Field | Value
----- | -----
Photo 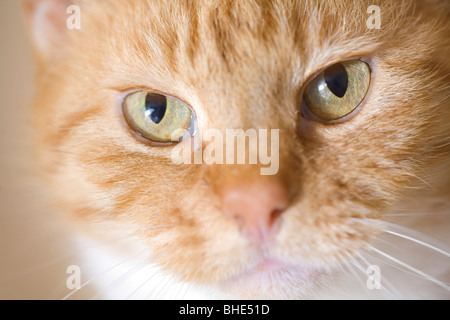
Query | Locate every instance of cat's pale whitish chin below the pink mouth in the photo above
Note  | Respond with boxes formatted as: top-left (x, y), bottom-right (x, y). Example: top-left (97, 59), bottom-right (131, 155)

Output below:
top-left (221, 259), bottom-right (324, 299)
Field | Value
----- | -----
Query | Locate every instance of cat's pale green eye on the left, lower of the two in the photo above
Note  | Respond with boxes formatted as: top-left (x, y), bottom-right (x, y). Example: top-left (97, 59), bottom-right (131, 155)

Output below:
top-left (122, 91), bottom-right (194, 142)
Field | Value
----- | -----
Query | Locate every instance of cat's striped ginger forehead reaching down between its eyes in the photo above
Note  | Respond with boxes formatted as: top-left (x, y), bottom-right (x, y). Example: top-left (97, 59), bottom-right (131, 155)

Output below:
top-left (76, 0), bottom-right (404, 125)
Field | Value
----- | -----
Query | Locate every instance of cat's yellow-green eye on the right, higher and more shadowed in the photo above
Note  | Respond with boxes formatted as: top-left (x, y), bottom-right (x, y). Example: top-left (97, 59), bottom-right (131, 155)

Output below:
top-left (303, 60), bottom-right (371, 121)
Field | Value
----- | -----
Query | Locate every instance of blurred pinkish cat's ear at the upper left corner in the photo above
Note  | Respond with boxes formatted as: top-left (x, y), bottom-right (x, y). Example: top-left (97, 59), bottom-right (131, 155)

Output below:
top-left (22, 0), bottom-right (73, 61)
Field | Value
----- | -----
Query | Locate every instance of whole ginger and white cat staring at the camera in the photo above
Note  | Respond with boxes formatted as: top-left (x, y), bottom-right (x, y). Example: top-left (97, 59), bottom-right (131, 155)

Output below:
top-left (24, 0), bottom-right (450, 299)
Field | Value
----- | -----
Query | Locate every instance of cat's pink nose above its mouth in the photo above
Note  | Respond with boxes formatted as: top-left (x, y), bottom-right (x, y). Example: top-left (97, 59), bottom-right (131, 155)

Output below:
top-left (222, 180), bottom-right (288, 241)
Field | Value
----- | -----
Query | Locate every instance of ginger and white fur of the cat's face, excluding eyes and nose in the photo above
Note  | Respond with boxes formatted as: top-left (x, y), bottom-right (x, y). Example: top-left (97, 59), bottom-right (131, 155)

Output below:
top-left (25, 0), bottom-right (450, 298)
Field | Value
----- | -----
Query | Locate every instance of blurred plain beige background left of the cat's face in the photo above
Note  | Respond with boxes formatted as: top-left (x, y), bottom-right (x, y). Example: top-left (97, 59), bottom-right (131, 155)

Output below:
top-left (0, 0), bottom-right (86, 299)
